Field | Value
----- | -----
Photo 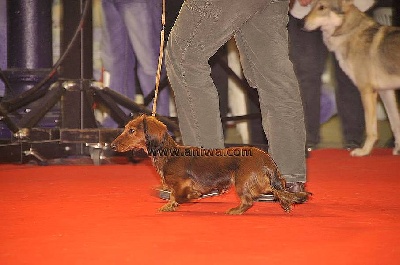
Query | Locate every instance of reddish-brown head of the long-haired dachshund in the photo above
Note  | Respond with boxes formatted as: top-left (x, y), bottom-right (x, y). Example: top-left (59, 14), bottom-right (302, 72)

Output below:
top-left (111, 115), bottom-right (168, 153)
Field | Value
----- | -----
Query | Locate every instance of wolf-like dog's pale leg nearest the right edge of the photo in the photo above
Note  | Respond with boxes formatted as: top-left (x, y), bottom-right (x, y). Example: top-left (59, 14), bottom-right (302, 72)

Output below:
top-left (378, 90), bottom-right (400, 155)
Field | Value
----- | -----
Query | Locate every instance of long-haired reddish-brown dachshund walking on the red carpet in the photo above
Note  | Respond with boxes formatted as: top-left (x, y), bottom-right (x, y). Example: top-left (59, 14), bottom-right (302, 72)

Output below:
top-left (111, 115), bottom-right (309, 214)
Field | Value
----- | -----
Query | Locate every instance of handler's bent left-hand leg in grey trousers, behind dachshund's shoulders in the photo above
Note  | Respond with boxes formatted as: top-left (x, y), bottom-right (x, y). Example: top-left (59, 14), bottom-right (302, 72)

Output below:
top-left (165, 0), bottom-right (268, 148)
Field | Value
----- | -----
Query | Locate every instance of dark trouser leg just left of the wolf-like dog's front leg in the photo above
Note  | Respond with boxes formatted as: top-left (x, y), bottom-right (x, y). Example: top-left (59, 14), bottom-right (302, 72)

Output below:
top-left (334, 58), bottom-right (365, 146)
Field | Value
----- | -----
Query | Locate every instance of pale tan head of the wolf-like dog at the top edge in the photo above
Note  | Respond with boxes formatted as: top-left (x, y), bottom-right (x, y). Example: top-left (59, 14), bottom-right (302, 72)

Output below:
top-left (304, 0), bottom-right (356, 35)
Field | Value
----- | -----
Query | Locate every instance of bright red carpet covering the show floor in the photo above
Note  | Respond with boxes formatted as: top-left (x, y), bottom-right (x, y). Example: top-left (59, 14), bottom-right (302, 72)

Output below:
top-left (0, 149), bottom-right (400, 265)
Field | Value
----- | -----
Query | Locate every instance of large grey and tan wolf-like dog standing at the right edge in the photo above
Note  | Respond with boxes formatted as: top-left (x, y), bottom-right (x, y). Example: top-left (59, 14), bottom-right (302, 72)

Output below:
top-left (305, 0), bottom-right (400, 156)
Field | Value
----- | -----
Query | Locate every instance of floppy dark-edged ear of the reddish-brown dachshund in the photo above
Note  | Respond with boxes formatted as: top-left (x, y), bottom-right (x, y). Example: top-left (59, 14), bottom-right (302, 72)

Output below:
top-left (143, 115), bottom-right (168, 153)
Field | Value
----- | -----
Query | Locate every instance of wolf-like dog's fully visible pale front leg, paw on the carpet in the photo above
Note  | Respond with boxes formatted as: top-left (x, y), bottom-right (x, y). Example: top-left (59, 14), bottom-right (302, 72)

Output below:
top-left (350, 88), bottom-right (378, 156)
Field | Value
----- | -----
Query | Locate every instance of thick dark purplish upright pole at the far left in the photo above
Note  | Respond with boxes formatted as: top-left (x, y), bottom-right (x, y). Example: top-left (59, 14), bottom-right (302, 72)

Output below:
top-left (5, 0), bottom-right (53, 98)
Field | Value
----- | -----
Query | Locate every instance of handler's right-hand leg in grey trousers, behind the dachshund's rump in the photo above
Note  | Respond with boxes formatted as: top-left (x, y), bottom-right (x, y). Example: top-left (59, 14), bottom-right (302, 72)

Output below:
top-left (236, 1), bottom-right (306, 182)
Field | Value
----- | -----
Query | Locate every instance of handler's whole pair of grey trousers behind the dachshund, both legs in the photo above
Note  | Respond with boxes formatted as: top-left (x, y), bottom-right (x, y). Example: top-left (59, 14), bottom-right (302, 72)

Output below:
top-left (165, 0), bottom-right (306, 182)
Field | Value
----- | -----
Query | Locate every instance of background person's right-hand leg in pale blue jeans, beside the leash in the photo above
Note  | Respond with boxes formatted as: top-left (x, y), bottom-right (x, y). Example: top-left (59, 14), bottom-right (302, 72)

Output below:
top-left (118, 0), bottom-right (169, 115)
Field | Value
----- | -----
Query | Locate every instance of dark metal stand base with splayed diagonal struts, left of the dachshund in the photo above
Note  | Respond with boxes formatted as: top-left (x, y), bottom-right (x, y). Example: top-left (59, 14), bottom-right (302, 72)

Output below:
top-left (0, 80), bottom-right (179, 165)
